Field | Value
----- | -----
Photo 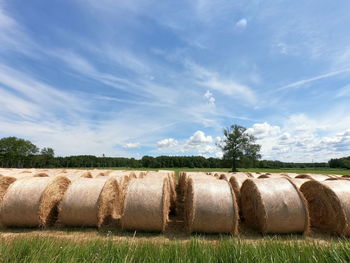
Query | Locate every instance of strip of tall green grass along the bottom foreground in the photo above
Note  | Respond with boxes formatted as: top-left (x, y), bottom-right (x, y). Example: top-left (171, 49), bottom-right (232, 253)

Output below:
top-left (0, 237), bottom-right (350, 262)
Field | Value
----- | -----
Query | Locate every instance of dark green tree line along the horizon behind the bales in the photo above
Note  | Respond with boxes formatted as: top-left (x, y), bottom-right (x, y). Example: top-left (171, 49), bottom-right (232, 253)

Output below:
top-left (0, 137), bottom-right (334, 168)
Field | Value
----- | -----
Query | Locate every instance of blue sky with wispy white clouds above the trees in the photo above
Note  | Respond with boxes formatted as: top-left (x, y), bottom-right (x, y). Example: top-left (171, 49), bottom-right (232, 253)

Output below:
top-left (0, 0), bottom-right (350, 162)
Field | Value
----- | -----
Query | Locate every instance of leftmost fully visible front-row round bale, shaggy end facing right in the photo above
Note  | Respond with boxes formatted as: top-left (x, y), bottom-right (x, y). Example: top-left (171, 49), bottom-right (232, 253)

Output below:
top-left (0, 176), bottom-right (70, 227)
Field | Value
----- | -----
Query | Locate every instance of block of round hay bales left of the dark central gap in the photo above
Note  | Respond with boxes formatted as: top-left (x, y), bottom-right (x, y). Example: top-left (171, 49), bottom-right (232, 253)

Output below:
top-left (0, 169), bottom-right (176, 231)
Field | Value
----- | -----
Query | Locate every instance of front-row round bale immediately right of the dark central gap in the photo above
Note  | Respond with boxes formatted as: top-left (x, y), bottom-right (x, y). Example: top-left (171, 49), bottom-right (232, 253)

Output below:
top-left (185, 178), bottom-right (239, 235)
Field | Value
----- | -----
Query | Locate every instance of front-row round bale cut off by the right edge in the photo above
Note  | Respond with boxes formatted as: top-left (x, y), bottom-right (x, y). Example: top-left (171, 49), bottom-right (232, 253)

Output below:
top-left (300, 180), bottom-right (350, 236)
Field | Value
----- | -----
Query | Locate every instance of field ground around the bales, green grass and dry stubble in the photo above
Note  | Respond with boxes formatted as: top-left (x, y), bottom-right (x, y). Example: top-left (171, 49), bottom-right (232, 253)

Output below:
top-left (0, 168), bottom-right (350, 262)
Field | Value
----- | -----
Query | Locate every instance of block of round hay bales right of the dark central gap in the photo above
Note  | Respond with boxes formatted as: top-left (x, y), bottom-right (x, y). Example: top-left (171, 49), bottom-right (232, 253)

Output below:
top-left (179, 173), bottom-right (350, 236)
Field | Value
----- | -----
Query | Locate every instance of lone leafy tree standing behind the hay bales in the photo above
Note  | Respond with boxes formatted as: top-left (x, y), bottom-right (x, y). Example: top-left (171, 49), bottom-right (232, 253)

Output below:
top-left (219, 124), bottom-right (261, 172)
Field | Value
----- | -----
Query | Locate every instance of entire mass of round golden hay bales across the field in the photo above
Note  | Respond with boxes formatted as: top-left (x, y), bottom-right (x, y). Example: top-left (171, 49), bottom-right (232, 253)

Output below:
top-left (0, 169), bottom-right (350, 236)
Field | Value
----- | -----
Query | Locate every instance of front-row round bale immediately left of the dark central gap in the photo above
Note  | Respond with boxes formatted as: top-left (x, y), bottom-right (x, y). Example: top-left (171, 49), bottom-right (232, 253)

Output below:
top-left (121, 178), bottom-right (170, 232)
